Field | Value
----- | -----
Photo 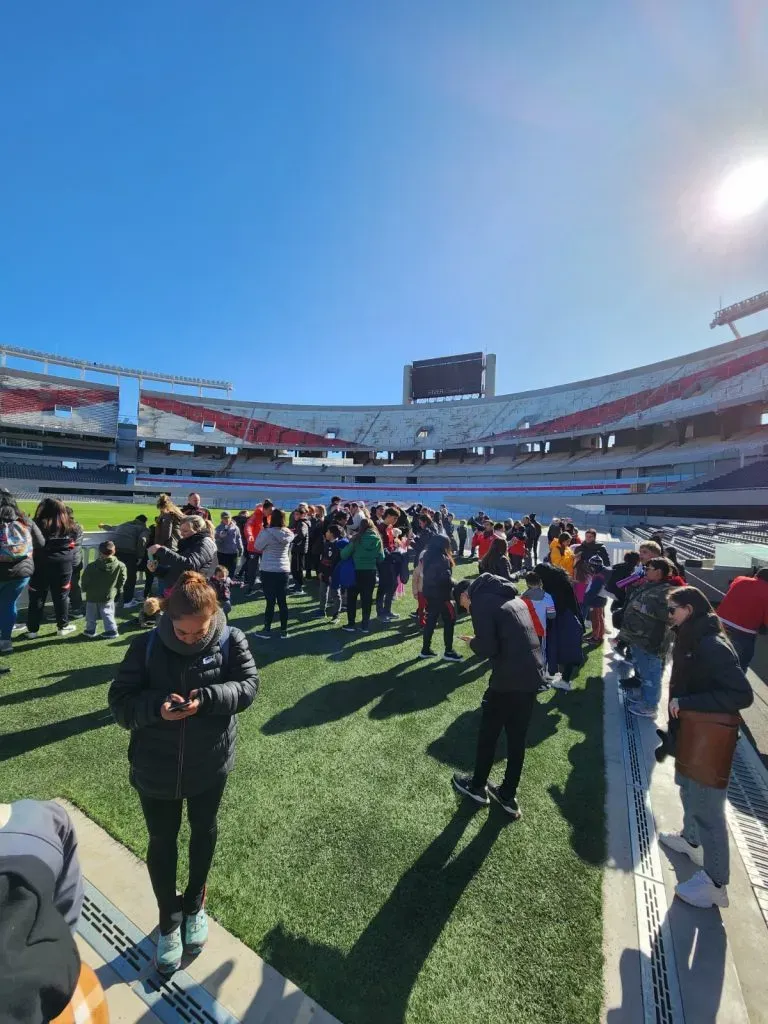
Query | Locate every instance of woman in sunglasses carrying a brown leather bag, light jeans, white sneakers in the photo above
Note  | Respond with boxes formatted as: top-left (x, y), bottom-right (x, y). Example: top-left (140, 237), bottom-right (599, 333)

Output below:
top-left (658, 587), bottom-right (754, 907)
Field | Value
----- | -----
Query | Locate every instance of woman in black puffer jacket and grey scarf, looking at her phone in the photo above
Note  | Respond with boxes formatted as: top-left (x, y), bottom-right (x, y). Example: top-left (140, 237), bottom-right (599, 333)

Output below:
top-left (108, 572), bottom-right (259, 974)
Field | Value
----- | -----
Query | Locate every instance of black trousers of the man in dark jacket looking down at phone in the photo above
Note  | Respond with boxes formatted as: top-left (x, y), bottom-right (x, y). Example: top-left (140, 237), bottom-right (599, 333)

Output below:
top-left (472, 689), bottom-right (536, 800)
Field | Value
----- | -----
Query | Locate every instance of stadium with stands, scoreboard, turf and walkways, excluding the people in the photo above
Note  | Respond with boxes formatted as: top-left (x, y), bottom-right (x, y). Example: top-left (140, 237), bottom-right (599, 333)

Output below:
top-left (0, 311), bottom-right (768, 1024)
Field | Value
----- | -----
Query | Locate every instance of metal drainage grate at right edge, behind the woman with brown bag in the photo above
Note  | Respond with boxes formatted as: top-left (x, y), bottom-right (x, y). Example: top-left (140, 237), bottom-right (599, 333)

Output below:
top-left (726, 737), bottom-right (768, 925)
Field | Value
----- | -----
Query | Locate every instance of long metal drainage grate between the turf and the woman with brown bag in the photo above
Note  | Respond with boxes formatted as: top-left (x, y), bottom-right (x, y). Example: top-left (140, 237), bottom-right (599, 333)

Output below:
top-left (618, 666), bottom-right (684, 1024)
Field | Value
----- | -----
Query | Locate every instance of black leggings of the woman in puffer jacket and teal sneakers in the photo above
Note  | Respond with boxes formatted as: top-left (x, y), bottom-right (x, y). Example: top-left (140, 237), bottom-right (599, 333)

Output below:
top-left (138, 777), bottom-right (226, 935)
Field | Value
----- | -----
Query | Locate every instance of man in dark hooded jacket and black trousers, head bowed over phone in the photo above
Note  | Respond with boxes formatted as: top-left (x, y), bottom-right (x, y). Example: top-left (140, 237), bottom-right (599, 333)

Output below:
top-left (453, 572), bottom-right (544, 819)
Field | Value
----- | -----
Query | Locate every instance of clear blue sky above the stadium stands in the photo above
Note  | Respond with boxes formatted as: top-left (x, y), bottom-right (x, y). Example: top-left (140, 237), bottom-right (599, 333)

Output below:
top-left (0, 0), bottom-right (768, 415)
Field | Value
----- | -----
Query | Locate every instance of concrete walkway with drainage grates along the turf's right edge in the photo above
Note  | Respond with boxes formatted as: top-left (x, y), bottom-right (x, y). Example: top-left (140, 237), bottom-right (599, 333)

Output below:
top-left (603, 644), bottom-right (768, 1024)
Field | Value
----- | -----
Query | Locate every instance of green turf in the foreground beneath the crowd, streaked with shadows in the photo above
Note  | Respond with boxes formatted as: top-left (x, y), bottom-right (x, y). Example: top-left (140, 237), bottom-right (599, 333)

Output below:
top-left (0, 505), bottom-right (604, 1024)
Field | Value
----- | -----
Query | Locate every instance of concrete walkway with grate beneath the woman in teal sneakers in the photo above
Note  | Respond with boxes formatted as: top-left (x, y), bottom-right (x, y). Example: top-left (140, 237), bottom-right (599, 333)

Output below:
top-left (60, 801), bottom-right (339, 1024)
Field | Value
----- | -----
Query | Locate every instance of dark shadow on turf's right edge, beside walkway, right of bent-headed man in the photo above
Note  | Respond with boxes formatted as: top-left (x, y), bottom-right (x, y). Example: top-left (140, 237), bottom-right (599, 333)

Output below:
top-left (549, 676), bottom-right (605, 864)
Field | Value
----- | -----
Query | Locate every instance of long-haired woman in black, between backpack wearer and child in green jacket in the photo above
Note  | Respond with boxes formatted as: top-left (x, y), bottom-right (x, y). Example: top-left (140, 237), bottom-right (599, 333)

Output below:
top-left (26, 498), bottom-right (75, 640)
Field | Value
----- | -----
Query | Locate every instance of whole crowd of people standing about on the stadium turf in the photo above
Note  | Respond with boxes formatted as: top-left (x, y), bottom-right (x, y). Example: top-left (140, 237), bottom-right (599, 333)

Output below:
top-left (0, 492), bottom-right (768, 999)
